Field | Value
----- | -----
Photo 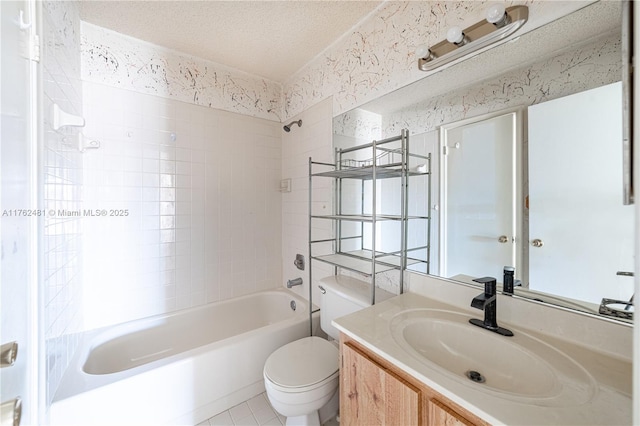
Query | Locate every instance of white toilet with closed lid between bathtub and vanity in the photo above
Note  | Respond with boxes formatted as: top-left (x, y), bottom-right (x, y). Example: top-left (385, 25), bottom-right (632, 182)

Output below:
top-left (263, 275), bottom-right (393, 425)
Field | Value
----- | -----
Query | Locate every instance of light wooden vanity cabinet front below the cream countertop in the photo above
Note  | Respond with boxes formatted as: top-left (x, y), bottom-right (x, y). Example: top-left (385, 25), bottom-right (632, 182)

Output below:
top-left (340, 335), bottom-right (488, 426)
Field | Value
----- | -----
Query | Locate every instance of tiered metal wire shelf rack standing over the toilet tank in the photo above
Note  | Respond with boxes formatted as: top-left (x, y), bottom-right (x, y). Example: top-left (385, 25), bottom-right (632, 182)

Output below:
top-left (309, 130), bottom-right (431, 304)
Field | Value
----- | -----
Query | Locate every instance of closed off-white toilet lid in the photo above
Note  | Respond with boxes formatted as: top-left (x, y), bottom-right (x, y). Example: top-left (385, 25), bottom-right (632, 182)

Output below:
top-left (264, 336), bottom-right (338, 388)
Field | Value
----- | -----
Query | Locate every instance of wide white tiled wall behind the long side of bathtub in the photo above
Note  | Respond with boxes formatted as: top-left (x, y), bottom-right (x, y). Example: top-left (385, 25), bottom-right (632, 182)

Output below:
top-left (83, 81), bottom-right (282, 329)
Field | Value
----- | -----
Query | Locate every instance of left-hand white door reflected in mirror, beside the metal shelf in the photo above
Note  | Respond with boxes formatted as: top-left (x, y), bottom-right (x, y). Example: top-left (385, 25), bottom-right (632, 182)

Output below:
top-left (440, 112), bottom-right (519, 281)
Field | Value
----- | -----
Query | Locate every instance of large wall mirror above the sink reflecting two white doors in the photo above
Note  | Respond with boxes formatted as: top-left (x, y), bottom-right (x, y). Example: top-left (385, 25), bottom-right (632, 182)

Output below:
top-left (333, 2), bottom-right (635, 320)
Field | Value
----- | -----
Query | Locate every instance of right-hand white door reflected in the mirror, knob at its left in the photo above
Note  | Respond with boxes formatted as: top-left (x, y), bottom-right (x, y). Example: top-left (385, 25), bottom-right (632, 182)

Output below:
top-left (528, 83), bottom-right (634, 304)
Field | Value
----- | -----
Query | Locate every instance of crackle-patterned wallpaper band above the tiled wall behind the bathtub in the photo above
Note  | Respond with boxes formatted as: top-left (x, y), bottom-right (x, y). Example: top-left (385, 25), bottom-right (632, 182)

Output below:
top-left (81, 22), bottom-right (282, 122)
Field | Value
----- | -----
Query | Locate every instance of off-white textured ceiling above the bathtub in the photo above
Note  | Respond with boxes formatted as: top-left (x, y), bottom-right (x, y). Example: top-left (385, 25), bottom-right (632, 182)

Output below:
top-left (80, 0), bottom-right (381, 82)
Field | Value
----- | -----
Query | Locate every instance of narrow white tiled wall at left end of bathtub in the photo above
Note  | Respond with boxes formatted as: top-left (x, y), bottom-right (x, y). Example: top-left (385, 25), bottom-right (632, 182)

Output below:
top-left (39, 1), bottom-right (83, 405)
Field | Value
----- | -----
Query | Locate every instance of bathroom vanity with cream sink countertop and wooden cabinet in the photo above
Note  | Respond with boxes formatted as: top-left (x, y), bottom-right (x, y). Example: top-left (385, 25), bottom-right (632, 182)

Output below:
top-left (334, 275), bottom-right (632, 425)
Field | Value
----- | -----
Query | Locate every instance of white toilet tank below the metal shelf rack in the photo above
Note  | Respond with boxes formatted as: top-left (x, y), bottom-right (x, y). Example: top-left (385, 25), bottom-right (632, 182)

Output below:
top-left (320, 275), bottom-right (394, 340)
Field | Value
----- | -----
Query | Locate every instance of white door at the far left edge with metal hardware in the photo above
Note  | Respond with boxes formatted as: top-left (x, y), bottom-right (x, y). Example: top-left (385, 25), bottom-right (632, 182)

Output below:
top-left (0, 1), bottom-right (37, 425)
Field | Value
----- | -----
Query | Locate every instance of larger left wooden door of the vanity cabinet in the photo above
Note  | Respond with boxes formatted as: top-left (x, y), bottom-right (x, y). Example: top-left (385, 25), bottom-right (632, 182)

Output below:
top-left (340, 343), bottom-right (421, 426)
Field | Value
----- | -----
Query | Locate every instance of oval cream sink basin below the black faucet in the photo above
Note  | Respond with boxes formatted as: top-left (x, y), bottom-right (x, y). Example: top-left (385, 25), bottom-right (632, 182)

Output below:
top-left (390, 309), bottom-right (596, 406)
